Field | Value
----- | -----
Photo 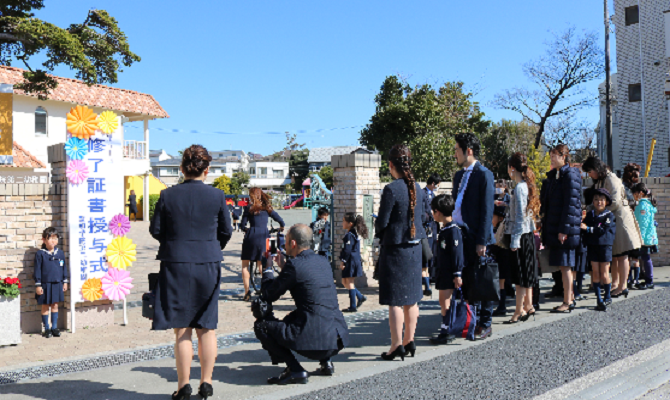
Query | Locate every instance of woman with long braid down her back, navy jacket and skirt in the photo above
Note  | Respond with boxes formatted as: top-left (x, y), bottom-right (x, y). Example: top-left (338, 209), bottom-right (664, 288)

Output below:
top-left (375, 145), bottom-right (426, 360)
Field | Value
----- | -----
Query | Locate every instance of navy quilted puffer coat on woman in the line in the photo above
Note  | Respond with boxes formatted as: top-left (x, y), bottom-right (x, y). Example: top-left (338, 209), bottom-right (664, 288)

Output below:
top-left (540, 164), bottom-right (582, 249)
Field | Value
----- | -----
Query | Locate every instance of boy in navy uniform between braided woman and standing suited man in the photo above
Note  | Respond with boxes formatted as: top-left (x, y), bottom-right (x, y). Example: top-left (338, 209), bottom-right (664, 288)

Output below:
top-left (430, 194), bottom-right (465, 344)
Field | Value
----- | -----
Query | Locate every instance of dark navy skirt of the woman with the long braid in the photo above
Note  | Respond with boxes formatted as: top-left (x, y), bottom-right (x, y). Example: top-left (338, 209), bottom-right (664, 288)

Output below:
top-left (379, 243), bottom-right (423, 307)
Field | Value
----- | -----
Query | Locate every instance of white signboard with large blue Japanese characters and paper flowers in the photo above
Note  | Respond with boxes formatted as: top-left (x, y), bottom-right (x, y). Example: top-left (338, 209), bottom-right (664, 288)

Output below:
top-left (67, 130), bottom-right (124, 304)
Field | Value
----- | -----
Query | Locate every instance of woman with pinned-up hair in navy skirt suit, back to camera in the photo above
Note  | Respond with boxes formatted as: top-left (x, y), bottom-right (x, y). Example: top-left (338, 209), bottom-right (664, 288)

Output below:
top-left (149, 145), bottom-right (233, 399)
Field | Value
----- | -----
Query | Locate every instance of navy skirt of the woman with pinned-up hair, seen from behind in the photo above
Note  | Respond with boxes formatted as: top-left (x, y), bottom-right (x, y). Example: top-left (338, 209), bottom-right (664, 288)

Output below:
top-left (152, 261), bottom-right (221, 330)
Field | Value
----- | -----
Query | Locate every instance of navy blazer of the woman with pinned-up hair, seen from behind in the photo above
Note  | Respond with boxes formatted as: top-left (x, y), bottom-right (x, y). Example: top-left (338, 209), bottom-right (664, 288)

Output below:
top-left (149, 179), bottom-right (233, 263)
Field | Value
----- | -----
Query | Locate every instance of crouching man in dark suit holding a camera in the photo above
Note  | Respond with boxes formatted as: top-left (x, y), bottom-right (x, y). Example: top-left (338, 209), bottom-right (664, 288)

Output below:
top-left (254, 224), bottom-right (349, 385)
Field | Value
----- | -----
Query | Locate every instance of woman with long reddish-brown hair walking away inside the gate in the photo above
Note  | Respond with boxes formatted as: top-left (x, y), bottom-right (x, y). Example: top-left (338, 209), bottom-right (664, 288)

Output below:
top-left (240, 188), bottom-right (284, 301)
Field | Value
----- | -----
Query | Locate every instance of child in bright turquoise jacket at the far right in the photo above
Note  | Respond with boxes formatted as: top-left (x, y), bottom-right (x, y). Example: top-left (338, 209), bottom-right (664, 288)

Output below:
top-left (632, 182), bottom-right (658, 290)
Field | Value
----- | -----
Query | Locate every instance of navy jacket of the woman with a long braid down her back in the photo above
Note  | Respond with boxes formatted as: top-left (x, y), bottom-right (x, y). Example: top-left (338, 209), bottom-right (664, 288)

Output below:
top-left (375, 179), bottom-right (426, 246)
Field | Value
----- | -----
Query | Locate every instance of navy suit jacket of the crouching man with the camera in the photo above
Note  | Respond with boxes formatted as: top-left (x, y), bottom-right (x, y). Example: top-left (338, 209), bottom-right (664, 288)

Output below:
top-left (261, 250), bottom-right (349, 350)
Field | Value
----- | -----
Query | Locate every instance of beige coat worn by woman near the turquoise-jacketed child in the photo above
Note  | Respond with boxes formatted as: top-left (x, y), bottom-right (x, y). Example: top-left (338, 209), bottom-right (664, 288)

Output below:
top-left (596, 172), bottom-right (642, 255)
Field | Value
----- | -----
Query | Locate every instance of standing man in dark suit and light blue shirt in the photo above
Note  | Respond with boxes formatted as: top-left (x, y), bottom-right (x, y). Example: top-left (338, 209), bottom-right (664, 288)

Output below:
top-left (451, 133), bottom-right (494, 339)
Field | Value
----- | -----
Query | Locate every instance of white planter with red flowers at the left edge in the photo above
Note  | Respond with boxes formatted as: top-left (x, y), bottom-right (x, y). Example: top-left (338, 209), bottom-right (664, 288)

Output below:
top-left (0, 278), bottom-right (21, 346)
